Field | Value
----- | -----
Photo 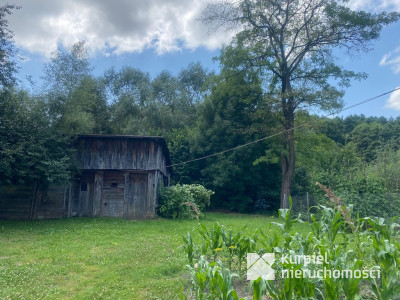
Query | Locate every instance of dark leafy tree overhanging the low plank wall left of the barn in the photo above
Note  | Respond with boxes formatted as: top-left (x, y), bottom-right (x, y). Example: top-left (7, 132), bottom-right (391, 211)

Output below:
top-left (0, 89), bottom-right (72, 187)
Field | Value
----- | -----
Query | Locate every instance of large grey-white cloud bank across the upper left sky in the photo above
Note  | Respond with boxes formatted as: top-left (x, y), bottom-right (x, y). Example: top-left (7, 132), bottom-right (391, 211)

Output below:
top-left (10, 0), bottom-right (231, 56)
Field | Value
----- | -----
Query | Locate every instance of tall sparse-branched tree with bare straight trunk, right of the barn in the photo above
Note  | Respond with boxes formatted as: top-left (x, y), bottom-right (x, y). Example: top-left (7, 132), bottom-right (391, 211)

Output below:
top-left (201, 0), bottom-right (399, 207)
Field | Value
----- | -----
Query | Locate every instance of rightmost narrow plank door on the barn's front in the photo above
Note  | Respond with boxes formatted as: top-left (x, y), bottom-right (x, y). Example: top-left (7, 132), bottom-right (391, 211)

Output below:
top-left (127, 173), bottom-right (148, 219)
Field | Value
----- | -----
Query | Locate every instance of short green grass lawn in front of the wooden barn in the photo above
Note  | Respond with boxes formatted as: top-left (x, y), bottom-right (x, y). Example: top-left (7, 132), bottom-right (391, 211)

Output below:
top-left (0, 213), bottom-right (308, 299)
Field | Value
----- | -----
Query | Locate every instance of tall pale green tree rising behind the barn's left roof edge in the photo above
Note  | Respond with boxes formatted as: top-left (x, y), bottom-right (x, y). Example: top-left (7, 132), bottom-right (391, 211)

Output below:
top-left (42, 42), bottom-right (109, 134)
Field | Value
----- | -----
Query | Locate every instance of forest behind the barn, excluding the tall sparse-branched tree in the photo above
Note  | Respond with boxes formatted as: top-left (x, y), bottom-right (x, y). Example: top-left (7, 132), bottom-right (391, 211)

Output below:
top-left (0, 5), bottom-right (400, 216)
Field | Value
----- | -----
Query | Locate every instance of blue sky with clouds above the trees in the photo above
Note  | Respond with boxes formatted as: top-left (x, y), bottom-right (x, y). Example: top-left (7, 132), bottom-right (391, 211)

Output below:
top-left (10, 0), bottom-right (400, 117)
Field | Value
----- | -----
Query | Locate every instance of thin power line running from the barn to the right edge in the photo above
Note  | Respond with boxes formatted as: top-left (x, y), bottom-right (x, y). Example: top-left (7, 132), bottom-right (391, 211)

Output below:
top-left (166, 87), bottom-right (400, 168)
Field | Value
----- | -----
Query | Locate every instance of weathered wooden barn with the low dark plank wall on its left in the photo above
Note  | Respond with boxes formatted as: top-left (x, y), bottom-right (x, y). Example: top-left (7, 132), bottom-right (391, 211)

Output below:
top-left (0, 135), bottom-right (171, 219)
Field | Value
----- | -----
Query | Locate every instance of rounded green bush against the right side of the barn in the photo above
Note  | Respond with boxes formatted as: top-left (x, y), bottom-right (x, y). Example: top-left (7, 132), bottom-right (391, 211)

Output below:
top-left (158, 184), bottom-right (214, 219)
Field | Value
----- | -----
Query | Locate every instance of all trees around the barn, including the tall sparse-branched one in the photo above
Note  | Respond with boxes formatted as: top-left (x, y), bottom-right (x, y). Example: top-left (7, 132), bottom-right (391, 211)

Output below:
top-left (0, 0), bottom-right (400, 213)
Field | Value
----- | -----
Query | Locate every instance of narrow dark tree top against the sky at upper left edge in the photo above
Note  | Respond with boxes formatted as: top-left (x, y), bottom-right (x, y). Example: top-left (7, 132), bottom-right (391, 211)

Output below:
top-left (0, 4), bottom-right (19, 88)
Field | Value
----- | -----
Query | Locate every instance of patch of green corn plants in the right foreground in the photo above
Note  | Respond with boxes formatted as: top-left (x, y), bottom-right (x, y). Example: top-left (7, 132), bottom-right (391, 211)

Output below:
top-left (184, 189), bottom-right (400, 300)
